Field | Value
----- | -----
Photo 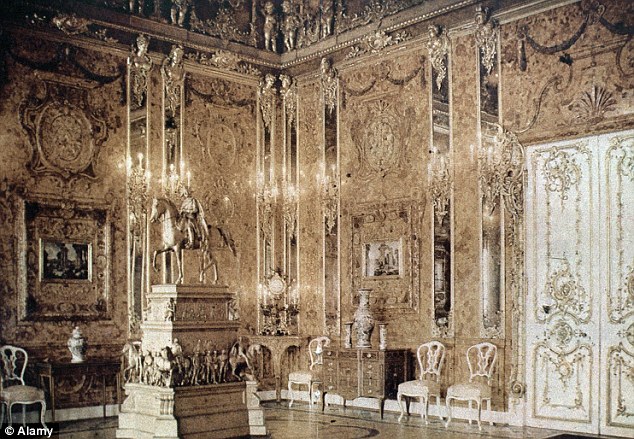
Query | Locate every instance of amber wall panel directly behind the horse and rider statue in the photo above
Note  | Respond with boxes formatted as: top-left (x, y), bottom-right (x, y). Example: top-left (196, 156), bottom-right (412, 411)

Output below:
top-left (183, 72), bottom-right (257, 334)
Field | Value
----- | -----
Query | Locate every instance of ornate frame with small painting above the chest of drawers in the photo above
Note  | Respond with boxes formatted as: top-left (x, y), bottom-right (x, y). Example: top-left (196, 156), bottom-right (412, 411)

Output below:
top-left (351, 200), bottom-right (421, 312)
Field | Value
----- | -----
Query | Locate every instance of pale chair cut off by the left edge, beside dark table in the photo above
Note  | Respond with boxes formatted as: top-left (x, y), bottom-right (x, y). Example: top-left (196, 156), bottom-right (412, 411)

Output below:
top-left (0, 345), bottom-right (46, 428)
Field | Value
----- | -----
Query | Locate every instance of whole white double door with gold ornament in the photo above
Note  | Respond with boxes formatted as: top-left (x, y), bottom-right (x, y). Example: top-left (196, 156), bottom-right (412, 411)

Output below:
top-left (525, 132), bottom-right (634, 435)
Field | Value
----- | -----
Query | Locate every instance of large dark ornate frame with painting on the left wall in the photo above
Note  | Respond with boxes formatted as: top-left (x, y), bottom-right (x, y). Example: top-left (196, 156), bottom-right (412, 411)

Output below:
top-left (17, 198), bottom-right (112, 322)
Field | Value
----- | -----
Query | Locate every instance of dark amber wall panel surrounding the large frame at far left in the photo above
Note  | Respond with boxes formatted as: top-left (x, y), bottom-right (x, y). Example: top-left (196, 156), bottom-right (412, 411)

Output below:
top-left (0, 32), bottom-right (127, 364)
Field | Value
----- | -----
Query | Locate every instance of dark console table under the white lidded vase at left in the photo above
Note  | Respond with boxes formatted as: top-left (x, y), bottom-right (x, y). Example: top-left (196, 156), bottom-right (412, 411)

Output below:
top-left (35, 359), bottom-right (121, 421)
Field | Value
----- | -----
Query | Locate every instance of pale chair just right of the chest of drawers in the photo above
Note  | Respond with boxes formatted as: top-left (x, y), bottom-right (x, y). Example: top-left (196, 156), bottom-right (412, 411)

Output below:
top-left (396, 341), bottom-right (445, 424)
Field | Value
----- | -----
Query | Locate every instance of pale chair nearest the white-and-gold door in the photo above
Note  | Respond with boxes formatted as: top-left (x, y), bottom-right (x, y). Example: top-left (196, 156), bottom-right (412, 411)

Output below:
top-left (445, 342), bottom-right (498, 430)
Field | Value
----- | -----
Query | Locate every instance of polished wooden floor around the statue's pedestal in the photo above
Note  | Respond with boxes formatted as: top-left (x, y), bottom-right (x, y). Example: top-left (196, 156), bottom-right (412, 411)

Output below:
top-left (18, 402), bottom-right (616, 439)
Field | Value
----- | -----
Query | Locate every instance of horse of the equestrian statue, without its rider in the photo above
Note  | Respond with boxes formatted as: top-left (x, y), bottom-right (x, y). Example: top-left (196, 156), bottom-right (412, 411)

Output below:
top-left (150, 198), bottom-right (236, 284)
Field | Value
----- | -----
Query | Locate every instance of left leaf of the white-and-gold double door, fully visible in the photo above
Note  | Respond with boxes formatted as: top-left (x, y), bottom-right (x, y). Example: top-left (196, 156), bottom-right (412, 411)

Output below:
top-left (526, 139), bottom-right (599, 433)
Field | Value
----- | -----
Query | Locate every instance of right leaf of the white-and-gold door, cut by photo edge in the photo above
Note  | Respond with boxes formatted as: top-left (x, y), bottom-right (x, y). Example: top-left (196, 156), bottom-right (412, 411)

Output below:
top-left (600, 132), bottom-right (634, 436)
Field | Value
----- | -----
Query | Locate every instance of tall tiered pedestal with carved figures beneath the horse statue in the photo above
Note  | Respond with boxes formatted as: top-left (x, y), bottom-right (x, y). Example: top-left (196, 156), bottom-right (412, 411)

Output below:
top-left (116, 285), bottom-right (250, 439)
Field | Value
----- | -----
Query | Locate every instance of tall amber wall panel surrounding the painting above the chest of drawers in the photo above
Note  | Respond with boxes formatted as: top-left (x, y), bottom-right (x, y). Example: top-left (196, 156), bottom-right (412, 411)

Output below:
top-left (340, 50), bottom-right (431, 347)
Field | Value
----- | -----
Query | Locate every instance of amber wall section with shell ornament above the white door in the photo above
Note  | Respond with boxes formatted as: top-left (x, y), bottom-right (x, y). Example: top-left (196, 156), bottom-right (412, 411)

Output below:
top-left (500, 0), bottom-right (634, 143)
